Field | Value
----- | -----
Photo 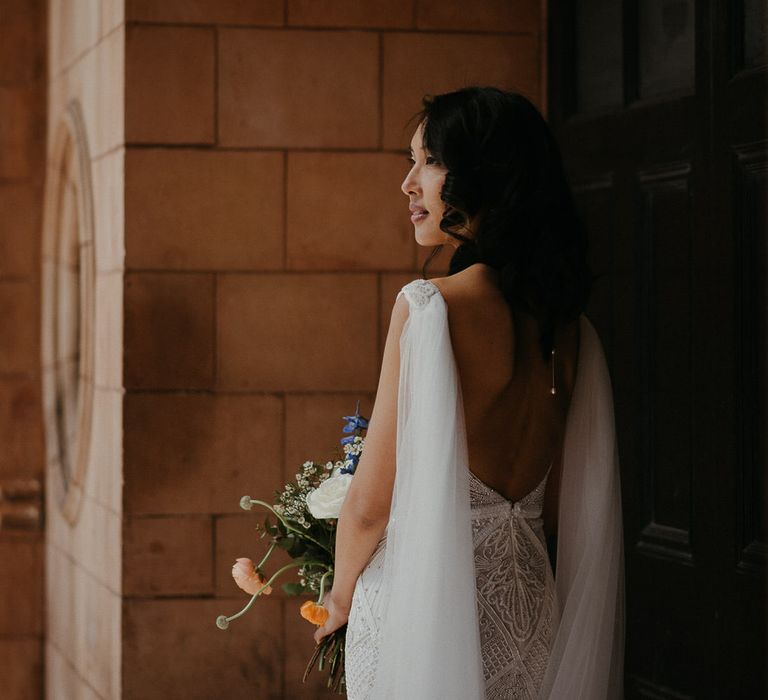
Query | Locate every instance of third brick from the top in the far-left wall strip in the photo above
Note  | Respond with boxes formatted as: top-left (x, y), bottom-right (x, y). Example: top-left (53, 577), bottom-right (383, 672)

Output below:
top-left (0, 183), bottom-right (42, 278)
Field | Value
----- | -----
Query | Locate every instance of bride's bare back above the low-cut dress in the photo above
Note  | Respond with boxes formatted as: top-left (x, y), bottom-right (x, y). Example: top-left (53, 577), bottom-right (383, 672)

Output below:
top-left (430, 264), bottom-right (579, 532)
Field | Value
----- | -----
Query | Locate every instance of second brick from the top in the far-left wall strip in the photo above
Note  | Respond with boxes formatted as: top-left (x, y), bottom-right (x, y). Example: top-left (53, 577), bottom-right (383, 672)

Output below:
top-left (0, 85), bottom-right (39, 180)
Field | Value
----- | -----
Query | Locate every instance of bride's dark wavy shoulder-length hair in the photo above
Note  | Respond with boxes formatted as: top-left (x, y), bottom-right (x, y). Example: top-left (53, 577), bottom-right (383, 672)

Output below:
top-left (409, 86), bottom-right (596, 360)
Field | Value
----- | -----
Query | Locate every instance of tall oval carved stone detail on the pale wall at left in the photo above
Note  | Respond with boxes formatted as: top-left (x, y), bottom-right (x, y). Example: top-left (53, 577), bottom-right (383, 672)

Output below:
top-left (42, 100), bottom-right (95, 524)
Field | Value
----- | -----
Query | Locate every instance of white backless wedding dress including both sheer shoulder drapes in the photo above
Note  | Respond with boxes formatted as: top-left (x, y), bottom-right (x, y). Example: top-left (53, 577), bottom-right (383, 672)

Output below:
top-left (345, 279), bottom-right (624, 700)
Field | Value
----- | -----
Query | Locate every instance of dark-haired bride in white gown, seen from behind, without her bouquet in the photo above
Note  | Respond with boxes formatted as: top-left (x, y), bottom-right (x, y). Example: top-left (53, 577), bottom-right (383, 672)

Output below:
top-left (315, 87), bottom-right (624, 700)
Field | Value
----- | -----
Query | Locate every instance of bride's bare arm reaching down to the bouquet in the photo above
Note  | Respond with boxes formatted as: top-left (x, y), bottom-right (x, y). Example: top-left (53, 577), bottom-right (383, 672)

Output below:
top-left (316, 294), bottom-right (408, 638)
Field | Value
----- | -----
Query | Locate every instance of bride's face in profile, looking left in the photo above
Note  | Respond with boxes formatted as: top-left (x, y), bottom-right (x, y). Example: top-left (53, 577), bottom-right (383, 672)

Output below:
top-left (400, 123), bottom-right (459, 247)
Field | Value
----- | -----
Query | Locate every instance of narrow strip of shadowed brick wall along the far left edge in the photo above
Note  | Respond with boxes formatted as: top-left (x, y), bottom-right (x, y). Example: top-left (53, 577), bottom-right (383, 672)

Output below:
top-left (0, 0), bottom-right (45, 700)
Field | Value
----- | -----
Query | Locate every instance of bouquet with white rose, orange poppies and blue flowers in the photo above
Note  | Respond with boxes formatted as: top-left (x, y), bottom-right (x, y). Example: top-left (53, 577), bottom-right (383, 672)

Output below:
top-left (216, 401), bottom-right (368, 693)
